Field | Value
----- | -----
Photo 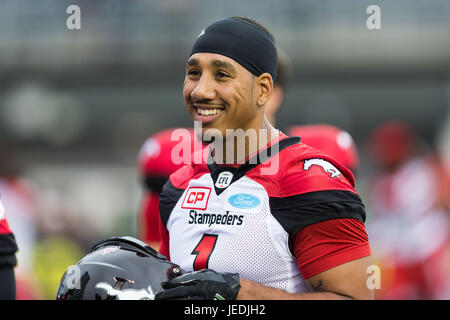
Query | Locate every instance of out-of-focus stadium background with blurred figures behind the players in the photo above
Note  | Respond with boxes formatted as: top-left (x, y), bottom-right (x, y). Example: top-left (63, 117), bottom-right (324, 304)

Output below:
top-left (0, 0), bottom-right (450, 299)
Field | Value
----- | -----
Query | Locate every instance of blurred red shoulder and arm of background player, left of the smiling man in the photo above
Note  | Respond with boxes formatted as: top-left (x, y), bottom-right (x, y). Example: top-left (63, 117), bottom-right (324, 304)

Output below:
top-left (138, 128), bottom-right (202, 250)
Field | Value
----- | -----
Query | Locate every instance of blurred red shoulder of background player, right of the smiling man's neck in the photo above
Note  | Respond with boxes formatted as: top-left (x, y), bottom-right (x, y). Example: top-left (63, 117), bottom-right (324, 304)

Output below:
top-left (288, 124), bottom-right (359, 174)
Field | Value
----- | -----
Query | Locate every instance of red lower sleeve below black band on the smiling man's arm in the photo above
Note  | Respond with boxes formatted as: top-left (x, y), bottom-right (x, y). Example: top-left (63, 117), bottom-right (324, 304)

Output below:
top-left (294, 219), bottom-right (371, 279)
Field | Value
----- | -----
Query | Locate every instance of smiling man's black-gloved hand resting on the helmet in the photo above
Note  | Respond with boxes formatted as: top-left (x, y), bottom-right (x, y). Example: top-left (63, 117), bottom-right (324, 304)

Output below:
top-left (155, 269), bottom-right (241, 300)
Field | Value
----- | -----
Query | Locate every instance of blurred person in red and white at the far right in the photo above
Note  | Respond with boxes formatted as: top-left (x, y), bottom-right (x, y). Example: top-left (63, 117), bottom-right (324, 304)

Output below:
top-left (368, 122), bottom-right (450, 299)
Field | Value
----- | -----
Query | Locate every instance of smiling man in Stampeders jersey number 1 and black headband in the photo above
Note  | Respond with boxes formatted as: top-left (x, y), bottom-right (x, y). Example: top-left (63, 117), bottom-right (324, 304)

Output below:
top-left (156, 17), bottom-right (373, 299)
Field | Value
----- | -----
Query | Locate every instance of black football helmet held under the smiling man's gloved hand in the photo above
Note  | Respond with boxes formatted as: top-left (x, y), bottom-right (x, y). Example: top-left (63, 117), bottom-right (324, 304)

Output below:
top-left (56, 236), bottom-right (185, 300)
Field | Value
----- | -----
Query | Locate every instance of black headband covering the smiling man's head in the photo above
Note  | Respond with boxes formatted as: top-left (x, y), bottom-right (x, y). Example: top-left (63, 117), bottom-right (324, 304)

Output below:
top-left (191, 17), bottom-right (277, 82)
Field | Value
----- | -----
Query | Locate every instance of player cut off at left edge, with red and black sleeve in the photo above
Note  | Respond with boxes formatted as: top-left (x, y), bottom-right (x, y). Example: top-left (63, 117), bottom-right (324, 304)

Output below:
top-left (0, 199), bottom-right (17, 300)
